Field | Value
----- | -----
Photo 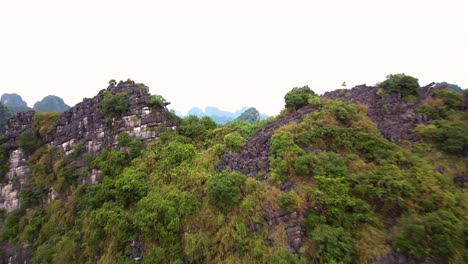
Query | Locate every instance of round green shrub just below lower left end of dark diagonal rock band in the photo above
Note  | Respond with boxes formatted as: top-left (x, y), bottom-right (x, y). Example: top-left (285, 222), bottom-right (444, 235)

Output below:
top-left (206, 171), bottom-right (245, 211)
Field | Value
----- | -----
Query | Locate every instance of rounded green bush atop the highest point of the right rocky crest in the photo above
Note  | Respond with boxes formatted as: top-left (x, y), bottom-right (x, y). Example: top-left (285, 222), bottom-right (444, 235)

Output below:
top-left (381, 73), bottom-right (421, 98)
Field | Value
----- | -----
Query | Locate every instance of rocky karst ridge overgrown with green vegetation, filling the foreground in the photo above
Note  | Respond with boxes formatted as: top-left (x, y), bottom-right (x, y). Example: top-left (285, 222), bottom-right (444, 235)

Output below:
top-left (1, 77), bottom-right (468, 263)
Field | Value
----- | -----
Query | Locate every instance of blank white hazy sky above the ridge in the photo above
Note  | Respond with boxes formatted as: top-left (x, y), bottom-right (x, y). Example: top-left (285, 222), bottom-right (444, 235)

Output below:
top-left (0, 0), bottom-right (468, 114)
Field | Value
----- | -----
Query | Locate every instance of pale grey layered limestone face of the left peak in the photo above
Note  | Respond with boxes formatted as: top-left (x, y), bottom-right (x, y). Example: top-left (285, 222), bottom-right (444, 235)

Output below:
top-left (51, 83), bottom-right (175, 154)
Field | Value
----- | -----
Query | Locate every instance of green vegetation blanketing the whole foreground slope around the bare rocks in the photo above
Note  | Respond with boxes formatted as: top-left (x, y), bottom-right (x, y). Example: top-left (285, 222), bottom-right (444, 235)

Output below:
top-left (0, 82), bottom-right (468, 263)
